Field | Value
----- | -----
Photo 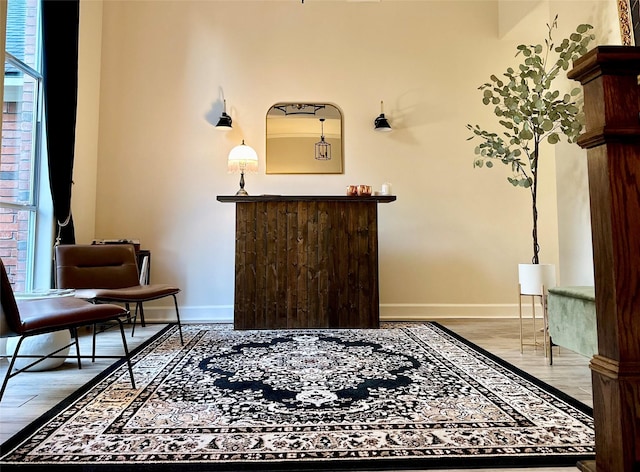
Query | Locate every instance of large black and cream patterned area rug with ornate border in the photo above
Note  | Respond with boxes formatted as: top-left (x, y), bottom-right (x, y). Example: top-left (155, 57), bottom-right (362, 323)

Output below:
top-left (0, 323), bottom-right (594, 472)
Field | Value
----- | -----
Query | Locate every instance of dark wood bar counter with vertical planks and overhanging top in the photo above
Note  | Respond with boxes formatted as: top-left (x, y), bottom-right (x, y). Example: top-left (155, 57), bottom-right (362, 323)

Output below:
top-left (217, 195), bottom-right (396, 329)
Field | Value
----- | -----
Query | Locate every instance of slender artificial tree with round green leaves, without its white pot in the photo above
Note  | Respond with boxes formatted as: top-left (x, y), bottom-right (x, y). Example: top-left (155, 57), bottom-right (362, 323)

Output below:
top-left (467, 16), bottom-right (595, 264)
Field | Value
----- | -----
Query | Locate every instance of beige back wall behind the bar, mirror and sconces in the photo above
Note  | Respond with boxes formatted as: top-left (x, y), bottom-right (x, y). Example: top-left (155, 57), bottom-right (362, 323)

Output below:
top-left (74, 0), bottom-right (619, 319)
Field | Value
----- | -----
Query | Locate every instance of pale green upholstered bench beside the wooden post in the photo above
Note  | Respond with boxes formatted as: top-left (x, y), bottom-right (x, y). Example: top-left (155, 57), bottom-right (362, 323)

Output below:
top-left (547, 286), bottom-right (598, 357)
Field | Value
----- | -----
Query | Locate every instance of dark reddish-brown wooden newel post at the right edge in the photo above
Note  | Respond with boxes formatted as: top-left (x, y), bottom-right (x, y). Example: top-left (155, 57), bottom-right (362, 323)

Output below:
top-left (569, 46), bottom-right (640, 472)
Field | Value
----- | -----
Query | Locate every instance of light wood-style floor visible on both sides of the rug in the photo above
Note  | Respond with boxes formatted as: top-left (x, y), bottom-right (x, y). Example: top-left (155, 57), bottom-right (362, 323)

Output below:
top-left (0, 319), bottom-right (592, 472)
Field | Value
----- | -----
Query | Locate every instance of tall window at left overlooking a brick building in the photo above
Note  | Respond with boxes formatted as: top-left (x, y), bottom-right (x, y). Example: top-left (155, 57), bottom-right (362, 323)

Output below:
top-left (0, 0), bottom-right (51, 292)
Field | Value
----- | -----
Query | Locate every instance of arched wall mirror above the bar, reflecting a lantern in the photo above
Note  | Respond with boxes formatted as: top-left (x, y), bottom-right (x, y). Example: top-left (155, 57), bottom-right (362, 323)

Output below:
top-left (266, 103), bottom-right (343, 174)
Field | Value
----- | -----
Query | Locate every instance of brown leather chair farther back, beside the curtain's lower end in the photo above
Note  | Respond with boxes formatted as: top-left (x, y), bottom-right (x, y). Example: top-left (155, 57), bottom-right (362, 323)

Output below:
top-left (55, 244), bottom-right (184, 344)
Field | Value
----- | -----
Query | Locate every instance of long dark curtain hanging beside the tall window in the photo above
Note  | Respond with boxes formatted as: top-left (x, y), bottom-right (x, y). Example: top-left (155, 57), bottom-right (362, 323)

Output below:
top-left (42, 0), bottom-right (80, 244)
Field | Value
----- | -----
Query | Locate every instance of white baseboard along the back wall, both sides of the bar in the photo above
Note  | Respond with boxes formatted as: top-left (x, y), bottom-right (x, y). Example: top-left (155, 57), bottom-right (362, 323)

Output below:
top-left (135, 299), bottom-right (542, 323)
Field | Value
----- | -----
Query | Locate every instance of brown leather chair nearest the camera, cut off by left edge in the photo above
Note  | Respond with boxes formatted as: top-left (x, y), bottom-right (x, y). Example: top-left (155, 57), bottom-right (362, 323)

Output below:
top-left (0, 259), bottom-right (136, 399)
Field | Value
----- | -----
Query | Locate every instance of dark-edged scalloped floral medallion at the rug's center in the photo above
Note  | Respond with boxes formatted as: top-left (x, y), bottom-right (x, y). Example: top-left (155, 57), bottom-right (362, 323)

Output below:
top-left (199, 334), bottom-right (420, 409)
